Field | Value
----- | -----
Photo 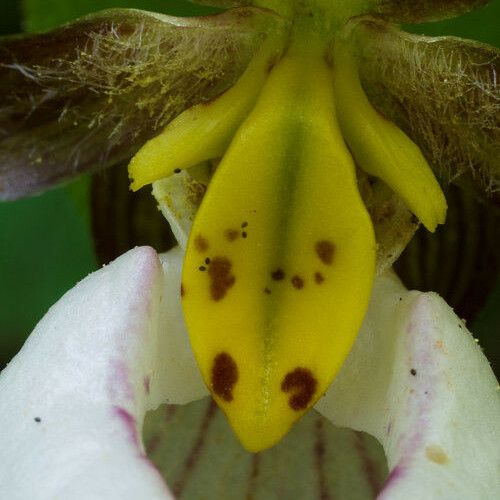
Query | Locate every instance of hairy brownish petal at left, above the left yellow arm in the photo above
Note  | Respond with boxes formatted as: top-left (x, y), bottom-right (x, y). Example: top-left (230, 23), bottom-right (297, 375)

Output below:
top-left (0, 8), bottom-right (274, 199)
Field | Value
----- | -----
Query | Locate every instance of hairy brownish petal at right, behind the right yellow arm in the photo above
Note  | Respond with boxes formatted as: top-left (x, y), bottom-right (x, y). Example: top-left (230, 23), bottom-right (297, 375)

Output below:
top-left (356, 19), bottom-right (500, 197)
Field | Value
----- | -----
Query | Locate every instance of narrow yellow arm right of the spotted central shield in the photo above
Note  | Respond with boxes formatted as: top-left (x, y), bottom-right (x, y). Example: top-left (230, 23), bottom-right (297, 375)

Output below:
top-left (334, 36), bottom-right (447, 232)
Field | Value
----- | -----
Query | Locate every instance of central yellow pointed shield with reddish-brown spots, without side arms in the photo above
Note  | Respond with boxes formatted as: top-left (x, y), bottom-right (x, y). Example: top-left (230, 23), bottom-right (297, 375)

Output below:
top-left (183, 41), bottom-right (375, 452)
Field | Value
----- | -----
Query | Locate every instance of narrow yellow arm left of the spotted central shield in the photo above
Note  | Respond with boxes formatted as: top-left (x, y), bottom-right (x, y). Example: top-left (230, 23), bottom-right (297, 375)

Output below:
top-left (129, 33), bottom-right (282, 191)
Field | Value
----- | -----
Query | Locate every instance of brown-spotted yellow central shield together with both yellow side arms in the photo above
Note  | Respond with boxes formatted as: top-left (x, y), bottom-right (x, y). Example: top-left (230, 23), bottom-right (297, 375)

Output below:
top-left (130, 26), bottom-right (446, 451)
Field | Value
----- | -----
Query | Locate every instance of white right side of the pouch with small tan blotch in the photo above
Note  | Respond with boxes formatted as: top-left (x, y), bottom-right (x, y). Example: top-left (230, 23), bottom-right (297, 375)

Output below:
top-left (317, 275), bottom-right (500, 500)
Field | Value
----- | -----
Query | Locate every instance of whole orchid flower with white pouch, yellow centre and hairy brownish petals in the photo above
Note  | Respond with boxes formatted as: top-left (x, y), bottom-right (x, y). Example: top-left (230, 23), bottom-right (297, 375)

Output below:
top-left (0, 0), bottom-right (500, 499)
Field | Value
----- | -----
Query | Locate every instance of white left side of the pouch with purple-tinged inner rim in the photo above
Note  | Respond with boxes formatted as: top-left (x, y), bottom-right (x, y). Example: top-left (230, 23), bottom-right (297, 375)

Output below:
top-left (0, 247), bottom-right (205, 500)
